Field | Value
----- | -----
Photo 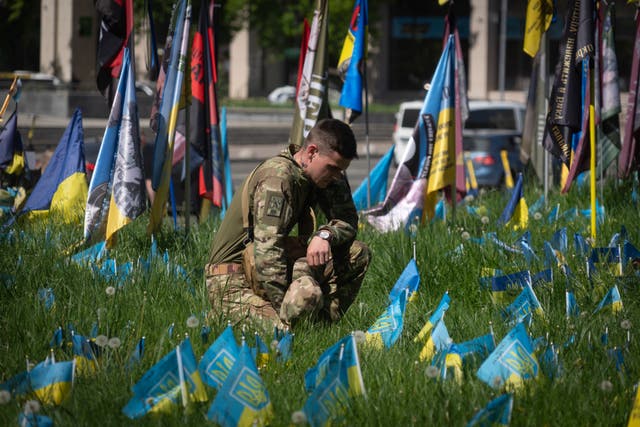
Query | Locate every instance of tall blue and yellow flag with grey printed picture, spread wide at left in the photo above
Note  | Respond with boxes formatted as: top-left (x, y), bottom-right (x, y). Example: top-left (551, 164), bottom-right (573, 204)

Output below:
top-left (84, 48), bottom-right (147, 247)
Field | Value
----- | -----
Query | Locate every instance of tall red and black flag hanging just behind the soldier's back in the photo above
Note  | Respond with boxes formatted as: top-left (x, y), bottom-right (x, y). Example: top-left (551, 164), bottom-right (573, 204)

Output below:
top-left (190, 0), bottom-right (224, 207)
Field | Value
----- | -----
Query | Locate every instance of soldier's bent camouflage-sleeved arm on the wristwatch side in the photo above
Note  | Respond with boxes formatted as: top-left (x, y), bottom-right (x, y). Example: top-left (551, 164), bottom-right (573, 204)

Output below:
top-left (318, 177), bottom-right (358, 246)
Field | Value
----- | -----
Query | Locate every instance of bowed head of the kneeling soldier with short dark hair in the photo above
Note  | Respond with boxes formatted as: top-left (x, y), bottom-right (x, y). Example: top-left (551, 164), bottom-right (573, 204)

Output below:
top-left (296, 119), bottom-right (358, 188)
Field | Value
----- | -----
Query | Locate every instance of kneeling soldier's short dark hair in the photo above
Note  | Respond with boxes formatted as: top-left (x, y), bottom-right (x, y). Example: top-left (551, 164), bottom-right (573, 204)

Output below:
top-left (304, 119), bottom-right (358, 160)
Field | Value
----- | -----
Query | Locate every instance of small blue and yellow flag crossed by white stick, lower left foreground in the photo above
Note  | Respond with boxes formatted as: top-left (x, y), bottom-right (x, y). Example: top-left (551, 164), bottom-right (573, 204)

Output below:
top-left (122, 338), bottom-right (207, 419)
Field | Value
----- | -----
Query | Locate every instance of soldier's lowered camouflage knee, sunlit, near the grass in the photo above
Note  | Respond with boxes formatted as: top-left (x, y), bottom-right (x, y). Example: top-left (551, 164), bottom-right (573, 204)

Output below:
top-left (280, 276), bottom-right (323, 325)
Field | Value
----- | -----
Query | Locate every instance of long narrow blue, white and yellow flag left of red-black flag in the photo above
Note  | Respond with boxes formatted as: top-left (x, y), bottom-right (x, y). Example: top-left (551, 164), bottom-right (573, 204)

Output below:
top-left (147, 0), bottom-right (191, 234)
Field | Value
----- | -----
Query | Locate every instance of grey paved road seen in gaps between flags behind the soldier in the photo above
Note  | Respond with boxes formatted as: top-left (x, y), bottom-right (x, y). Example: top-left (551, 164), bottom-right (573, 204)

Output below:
top-left (18, 111), bottom-right (393, 189)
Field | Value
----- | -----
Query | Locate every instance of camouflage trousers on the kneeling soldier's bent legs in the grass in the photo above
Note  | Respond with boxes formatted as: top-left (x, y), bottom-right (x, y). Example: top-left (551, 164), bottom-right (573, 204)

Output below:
top-left (206, 240), bottom-right (371, 328)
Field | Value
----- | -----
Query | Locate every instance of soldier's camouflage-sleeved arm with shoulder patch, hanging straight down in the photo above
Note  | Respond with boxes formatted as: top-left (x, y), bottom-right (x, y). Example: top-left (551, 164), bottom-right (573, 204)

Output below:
top-left (253, 176), bottom-right (292, 311)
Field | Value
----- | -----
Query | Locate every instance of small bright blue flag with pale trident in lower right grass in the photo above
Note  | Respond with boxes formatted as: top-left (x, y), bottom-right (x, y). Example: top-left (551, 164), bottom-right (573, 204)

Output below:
top-left (477, 323), bottom-right (539, 389)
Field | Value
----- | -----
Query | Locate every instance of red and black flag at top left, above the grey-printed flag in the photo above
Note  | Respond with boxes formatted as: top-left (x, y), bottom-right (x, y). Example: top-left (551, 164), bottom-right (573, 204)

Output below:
top-left (95, 0), bottom-right (133, 105)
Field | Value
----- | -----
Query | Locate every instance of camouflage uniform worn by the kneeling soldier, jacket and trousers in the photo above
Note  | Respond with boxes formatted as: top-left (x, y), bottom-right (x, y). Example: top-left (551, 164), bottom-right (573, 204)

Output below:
top-left (205, 146), bottom-right (370, 326)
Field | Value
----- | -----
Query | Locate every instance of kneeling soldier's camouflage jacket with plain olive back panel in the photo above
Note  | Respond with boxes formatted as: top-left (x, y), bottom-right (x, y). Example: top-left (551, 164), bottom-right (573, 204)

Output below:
top-left (209, 150), bottom-right (358, 309)
